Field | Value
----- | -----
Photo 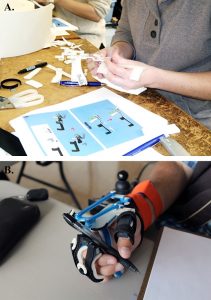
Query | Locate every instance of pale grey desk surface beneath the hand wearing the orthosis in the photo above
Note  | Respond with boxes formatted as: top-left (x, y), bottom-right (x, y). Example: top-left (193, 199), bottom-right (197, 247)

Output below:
top-left (0, 181), bottom-right (153, 300)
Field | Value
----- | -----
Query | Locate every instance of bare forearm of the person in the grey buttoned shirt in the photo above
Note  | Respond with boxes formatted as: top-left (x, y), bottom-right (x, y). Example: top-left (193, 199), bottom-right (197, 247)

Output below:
top-left (146, 68), bottom-right (211, 100)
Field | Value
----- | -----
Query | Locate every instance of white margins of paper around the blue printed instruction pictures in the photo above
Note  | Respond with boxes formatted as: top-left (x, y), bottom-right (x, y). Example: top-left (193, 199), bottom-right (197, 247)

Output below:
top-left (10, 88), bottom-right (178, 160)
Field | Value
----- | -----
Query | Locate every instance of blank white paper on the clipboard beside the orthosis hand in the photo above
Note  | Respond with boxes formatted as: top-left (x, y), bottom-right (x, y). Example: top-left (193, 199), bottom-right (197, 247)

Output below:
top-left (144, 228), bottom-right (211, 300)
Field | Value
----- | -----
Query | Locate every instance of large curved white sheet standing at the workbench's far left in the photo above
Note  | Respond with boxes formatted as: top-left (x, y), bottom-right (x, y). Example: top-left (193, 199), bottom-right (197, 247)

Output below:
top-left (0, 4), bottom-right (54, 58)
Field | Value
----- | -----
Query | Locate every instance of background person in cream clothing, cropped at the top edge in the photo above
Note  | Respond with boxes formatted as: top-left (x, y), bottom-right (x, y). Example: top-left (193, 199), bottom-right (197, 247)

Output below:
top-left (37, 0), bottom-right (111, 48)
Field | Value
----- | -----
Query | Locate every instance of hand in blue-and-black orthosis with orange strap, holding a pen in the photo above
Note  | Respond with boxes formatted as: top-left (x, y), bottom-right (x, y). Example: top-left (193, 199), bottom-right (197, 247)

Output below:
top-left (64, 171), bottom-right (162, 282)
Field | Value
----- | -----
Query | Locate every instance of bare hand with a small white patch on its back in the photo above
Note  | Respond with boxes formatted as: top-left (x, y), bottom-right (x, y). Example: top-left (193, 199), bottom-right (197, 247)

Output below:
top-left (98, 55), bottom-right (159, 89)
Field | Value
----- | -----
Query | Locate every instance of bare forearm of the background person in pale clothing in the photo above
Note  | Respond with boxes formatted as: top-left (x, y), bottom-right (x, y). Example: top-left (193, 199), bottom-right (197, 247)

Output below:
top-left (55, 0), bottom-right (101, 22)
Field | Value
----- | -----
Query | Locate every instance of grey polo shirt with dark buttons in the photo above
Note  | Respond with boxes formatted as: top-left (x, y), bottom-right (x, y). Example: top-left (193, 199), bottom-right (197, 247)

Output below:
top-left (112, 0), bottom-right (211, 129)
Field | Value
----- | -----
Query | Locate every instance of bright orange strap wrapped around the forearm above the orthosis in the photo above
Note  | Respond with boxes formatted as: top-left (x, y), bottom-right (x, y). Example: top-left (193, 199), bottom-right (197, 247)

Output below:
top-left (128, 180), bottom-right (163, 230)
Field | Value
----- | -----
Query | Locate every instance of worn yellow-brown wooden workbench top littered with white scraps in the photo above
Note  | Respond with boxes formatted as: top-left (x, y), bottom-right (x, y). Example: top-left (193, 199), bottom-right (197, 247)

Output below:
top-left (0, 36), bottom-right (211, 156)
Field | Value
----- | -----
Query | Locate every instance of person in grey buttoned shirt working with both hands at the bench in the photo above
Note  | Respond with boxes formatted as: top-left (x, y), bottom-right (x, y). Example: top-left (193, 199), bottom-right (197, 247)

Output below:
top-left (88, 0), bottom-right (211, 129)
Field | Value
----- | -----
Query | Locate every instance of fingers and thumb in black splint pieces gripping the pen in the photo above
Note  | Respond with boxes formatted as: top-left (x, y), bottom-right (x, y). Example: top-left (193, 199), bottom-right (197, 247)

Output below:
top-left (71, 208), bottom-right (144, 282)
